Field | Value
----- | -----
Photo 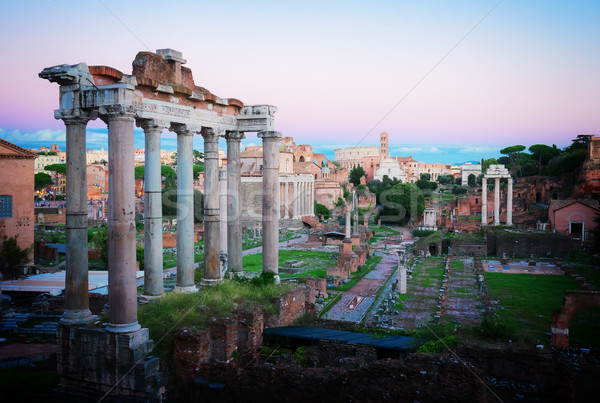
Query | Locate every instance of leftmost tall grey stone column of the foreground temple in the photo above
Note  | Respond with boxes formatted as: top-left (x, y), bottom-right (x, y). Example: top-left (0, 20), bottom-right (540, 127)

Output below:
top-left (60, 116), bottom-right (93, 325)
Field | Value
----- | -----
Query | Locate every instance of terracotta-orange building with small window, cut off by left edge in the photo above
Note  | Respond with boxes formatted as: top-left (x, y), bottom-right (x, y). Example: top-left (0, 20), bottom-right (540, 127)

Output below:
top-left (0, 139), bottom-right (36, 258)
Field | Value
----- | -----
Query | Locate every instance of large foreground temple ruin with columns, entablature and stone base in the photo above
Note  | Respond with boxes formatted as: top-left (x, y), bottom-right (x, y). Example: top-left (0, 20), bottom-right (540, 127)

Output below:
top-left (39, 49), bottom-right (281, 400)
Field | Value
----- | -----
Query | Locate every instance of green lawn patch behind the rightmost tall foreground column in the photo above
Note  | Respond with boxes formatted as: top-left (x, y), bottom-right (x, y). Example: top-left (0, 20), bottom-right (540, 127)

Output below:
top-left (242, 250), bottom-right (337, 278)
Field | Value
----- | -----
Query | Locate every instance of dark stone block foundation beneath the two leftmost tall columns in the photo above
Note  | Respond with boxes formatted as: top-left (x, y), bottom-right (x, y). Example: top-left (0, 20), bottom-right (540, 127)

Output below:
top-left (57, 325), bottom-right (166, 402)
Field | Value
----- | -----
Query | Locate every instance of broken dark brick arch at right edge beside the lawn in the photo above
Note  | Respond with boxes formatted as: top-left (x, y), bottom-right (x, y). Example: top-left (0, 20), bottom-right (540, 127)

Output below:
top-left (550, 290), bottom-right (600, 348)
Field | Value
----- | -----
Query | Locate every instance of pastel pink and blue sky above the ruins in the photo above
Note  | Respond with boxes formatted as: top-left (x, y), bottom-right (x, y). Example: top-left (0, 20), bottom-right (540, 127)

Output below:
top-left (0, 0), bottom-right (600, 163)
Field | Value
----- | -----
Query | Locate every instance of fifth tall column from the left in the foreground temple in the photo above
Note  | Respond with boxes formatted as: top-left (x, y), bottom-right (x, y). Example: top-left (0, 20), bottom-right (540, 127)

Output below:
top-left (202, 127), bottom-right (221, 284)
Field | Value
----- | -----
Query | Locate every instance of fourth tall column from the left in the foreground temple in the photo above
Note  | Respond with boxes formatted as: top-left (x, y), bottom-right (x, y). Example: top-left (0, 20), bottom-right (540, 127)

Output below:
top-left (173, 125), bottom-right (196, 292)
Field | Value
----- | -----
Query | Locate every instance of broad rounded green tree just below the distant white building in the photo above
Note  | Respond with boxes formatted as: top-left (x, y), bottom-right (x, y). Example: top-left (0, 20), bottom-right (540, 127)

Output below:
top-left (379, 183), bottom-right (425, 225)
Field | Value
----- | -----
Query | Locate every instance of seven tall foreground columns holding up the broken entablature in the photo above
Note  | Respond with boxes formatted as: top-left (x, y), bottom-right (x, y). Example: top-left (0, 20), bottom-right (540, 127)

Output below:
top-left (61, 105), bottom-right (281, 333)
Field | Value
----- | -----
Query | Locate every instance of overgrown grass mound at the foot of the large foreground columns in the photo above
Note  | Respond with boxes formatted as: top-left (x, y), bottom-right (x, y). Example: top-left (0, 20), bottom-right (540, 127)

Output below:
top-left (138, 280), bottom-right (292, 357)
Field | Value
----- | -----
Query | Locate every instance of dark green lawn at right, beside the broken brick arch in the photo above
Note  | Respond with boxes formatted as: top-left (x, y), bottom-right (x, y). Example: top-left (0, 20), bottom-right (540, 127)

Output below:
top-left (485, 273), bottom-right (579, 342)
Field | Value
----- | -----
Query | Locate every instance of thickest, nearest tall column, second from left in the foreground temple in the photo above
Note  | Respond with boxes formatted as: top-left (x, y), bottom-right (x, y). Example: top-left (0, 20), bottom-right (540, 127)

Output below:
top-left (100, 105), bottom-right (141, 333)
